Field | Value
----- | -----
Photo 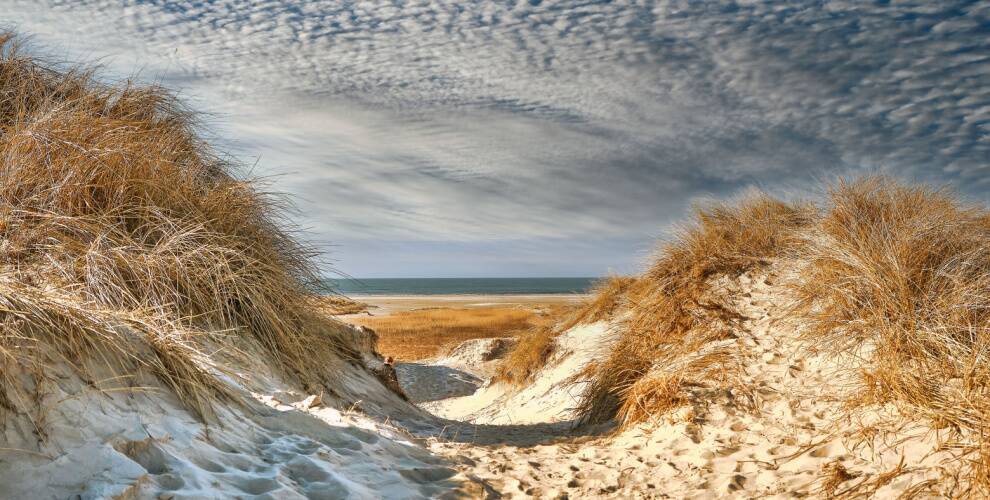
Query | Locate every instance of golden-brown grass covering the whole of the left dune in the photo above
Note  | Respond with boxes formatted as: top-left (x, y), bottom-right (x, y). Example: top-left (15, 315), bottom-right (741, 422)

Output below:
top-left (0, 34), bottom-right (349, 422)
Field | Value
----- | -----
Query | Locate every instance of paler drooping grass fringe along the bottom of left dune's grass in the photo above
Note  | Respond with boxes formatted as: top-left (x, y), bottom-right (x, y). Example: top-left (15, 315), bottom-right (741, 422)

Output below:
top-left (0, 275), bottom-right (237, 422)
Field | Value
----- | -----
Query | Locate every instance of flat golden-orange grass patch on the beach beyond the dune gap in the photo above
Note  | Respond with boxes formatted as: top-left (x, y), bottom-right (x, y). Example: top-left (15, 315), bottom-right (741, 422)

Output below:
top-left (349, 306), bottom-right (554, 360)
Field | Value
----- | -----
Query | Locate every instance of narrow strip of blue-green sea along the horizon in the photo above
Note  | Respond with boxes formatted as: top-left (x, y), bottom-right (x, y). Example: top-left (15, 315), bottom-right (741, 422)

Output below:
top-left (323, 278), bottom-right (600, 295)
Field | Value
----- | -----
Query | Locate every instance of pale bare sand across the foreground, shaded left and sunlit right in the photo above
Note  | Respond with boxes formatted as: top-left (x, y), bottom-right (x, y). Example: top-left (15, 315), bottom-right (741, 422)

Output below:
top-left (0, 275), bottom-right (948, 499)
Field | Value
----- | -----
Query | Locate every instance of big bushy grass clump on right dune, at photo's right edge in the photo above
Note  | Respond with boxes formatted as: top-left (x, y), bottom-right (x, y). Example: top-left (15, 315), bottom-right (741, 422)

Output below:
top-left (794, 177), bottom-right (990, 492)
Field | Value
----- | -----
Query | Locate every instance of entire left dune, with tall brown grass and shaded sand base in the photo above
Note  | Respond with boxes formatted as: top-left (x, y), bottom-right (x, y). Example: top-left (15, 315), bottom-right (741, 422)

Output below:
top-left (0, 35), bottom-right (478, 498)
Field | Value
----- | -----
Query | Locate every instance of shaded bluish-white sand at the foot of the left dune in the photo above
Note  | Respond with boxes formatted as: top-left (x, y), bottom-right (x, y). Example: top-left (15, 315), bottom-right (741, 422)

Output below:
top-left (0, 326), bottom-right (478, 499)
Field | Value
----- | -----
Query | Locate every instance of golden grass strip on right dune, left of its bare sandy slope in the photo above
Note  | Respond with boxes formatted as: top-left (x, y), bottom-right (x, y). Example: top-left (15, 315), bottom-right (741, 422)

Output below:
top-left (580, 193), bottom-right (816, 425)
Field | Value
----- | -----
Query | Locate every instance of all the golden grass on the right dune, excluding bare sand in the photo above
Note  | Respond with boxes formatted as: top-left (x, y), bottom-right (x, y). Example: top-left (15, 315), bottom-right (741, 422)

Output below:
top-left (564, 177), bottom-right (990, 497)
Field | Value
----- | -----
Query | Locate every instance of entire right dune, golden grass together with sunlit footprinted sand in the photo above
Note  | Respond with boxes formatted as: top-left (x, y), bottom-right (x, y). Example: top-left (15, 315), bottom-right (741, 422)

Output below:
top-left (429, 178), bottom-right (990, 498)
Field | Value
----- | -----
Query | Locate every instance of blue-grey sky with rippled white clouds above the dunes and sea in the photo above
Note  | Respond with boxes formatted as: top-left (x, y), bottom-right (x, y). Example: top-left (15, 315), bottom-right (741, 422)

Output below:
top-left (0, 0), bottom-right (990, 277)
